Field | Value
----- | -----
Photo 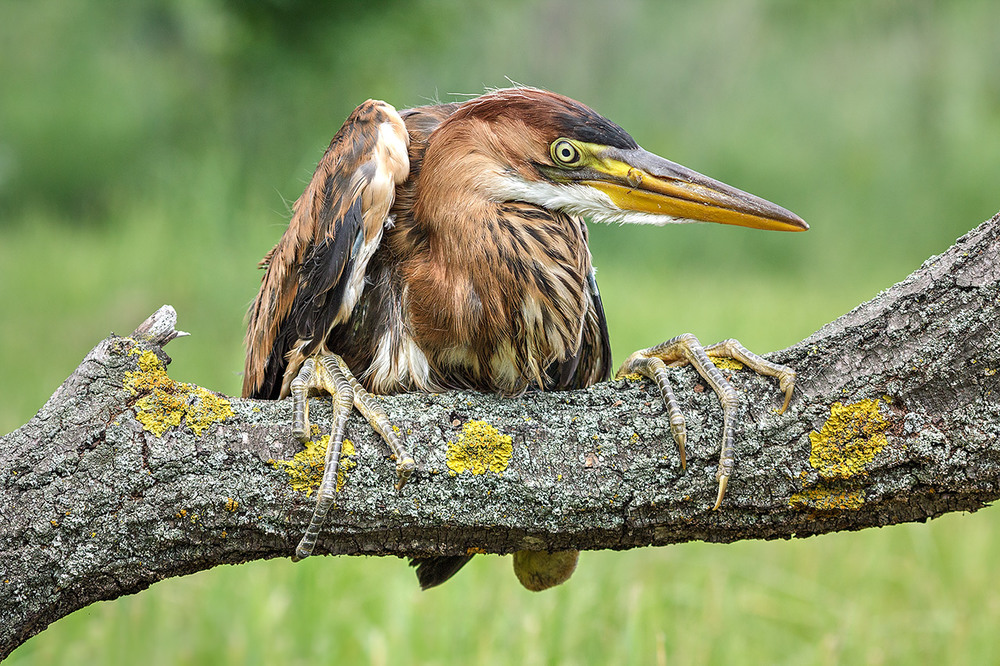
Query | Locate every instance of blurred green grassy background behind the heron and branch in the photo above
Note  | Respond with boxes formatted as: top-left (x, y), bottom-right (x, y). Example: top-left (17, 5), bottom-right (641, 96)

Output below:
top-left (0, 0), bottom-right (1000, 666)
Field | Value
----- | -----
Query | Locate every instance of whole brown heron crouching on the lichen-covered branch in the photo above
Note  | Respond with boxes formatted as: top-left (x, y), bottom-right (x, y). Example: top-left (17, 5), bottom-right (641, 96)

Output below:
top-left (243, 87), bottom-right (808, 589)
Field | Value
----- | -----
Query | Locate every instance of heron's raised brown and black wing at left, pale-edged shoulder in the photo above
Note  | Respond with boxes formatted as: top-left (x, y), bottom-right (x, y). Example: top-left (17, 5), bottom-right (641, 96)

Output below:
top-left (243, 100), bottom-right (410, 398)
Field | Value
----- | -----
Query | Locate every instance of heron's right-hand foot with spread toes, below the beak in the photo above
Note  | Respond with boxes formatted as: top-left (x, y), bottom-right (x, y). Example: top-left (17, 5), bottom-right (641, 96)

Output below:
top-left (616, 333), bottom-right (795, 511)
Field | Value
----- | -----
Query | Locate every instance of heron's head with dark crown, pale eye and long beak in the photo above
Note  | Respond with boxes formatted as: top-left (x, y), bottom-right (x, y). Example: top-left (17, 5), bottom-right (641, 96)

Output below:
top-left (428, 88), bottom-right (809, 231)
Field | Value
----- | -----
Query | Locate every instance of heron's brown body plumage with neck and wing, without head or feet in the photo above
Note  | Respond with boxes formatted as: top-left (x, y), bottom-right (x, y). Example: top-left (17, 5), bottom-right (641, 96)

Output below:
top-left (243, 91), bottom-right (611, 398)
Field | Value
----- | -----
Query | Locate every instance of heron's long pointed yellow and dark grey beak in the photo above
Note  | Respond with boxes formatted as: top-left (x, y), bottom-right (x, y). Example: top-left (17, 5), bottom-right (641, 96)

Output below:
top-left (581, 147), bottom-right (809, 231)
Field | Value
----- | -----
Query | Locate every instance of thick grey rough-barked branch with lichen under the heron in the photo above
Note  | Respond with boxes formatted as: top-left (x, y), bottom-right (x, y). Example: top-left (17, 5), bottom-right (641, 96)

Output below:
top-left (0, 215), bottom-right (1000, 657)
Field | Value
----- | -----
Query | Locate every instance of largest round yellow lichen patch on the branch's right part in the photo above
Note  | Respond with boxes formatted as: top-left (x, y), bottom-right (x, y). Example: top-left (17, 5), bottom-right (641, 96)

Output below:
top-left (809, 400), bottom-right (889, 479)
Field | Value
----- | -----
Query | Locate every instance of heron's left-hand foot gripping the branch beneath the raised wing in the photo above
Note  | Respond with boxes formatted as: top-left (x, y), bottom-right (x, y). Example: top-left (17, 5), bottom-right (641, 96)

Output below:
top-left (291, 354), bottom-right (416, 560)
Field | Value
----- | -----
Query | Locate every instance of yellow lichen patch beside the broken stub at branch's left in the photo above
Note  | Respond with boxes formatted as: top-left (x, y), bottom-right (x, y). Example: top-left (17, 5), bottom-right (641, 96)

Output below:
top-left (125, 350), bottom-right (233, 437)
